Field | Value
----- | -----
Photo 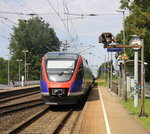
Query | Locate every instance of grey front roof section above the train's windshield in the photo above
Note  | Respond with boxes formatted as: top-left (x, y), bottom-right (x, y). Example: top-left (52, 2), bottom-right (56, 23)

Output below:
top-left (45, 52), bottom-right (79, 60)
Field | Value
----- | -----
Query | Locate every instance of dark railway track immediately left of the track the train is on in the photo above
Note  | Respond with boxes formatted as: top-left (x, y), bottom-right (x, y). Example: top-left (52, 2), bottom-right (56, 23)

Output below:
top-left (0, 99), bottom-right (44, 116)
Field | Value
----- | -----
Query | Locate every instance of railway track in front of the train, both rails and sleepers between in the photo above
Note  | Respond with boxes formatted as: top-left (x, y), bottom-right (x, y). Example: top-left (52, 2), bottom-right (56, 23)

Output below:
top-left (9, 108), bottom-right (73, 134)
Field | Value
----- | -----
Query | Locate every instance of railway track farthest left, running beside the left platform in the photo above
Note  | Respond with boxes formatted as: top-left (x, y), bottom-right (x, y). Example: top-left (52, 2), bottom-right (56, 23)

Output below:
top-left (0, 91), bottom-right (40, 104)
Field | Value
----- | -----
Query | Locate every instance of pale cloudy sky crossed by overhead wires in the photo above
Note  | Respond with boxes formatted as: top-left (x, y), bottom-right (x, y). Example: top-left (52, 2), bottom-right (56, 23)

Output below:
top-left (0, 0), bottom-right (126, 74)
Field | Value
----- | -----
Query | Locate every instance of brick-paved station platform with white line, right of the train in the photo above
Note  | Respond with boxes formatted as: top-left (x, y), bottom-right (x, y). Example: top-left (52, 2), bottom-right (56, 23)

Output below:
top-left (73, 86), bottom-right (150, 134)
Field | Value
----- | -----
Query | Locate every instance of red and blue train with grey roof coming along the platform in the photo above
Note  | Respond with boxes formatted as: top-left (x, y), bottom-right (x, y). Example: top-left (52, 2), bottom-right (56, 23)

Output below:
top-left (40, 52), bottom-right (93, 105)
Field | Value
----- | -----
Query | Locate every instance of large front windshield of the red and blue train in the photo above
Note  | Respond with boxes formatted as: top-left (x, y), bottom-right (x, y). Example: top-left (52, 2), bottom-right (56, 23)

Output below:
top-left (46, 59), bottom-right (75, 82)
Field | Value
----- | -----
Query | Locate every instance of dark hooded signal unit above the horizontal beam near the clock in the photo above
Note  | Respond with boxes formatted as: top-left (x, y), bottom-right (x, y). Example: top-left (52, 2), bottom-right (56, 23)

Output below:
top-left (99, 32), bottom-right (115, 47)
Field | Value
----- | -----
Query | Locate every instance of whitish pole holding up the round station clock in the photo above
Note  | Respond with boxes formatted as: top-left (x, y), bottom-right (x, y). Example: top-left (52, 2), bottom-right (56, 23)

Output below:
top-left (134, 50), bottom-right (138, 108)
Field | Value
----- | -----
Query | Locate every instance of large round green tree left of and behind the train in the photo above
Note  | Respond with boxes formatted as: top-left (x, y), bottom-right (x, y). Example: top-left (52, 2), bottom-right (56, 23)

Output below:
top-left (10, 17), bottom-right (60, 79)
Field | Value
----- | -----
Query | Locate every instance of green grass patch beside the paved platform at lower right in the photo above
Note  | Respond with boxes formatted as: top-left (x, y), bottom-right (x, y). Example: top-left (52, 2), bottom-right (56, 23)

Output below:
top-left (121, 99), bottom-right (150, 131)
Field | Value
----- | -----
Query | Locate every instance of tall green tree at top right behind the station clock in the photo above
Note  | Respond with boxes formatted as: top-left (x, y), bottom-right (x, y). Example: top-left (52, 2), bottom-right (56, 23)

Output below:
top-left (117, 0), bottom-right (150, 81)
